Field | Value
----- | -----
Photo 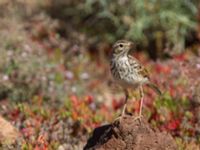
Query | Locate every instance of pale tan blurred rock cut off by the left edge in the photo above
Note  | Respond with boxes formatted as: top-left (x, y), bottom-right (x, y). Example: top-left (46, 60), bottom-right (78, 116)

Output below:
top-left (0, 116), bottom-right (20, 145)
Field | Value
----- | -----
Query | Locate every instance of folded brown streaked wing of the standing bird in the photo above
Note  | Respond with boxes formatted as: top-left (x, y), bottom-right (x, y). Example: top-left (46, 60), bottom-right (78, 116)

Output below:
top-left (128, 55), bottom-right (150, 79)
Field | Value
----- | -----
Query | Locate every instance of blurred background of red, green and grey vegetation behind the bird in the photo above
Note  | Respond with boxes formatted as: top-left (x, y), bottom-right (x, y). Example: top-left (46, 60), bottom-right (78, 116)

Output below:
top-left (0, 0), bottom-right (200, 150)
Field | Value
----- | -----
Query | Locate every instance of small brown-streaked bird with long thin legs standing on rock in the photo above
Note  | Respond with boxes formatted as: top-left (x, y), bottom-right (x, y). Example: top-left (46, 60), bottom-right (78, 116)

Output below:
top-left (110, 40), bottom-right (162, 120)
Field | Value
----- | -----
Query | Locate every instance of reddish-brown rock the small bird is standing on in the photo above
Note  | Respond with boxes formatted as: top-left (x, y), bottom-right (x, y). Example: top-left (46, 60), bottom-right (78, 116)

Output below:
top-left (84, 115), bottom-right (177, 150)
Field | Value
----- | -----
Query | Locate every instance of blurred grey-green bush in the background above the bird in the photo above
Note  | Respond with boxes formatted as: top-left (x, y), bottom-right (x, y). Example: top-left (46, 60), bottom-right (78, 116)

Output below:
top-left (65, 0), bottom-right (198, 51)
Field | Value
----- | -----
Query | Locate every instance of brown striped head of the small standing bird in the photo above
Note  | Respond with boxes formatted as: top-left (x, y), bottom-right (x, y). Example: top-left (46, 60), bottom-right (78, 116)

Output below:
top-left (112, 40), bottom-right (134, 56)
